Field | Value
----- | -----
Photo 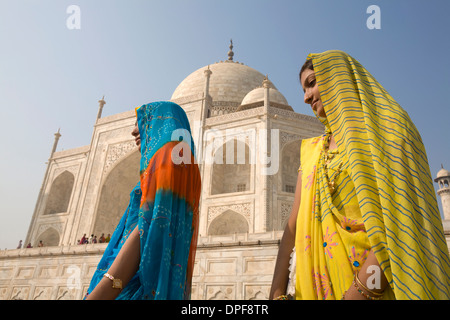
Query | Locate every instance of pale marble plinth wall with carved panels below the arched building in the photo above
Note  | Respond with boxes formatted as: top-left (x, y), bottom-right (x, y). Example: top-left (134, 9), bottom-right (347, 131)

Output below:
top-left (0, 232), bottom-right (281, 300)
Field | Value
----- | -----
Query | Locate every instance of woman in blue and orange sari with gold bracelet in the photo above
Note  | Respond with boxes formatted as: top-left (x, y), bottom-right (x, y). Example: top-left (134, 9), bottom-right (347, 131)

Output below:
top-left (85, 102), bottom-right (201, 300)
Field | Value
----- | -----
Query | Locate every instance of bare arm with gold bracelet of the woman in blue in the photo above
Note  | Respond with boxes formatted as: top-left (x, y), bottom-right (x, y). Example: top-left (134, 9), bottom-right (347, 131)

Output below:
top-left (86, 227), bottom-right (140, 300)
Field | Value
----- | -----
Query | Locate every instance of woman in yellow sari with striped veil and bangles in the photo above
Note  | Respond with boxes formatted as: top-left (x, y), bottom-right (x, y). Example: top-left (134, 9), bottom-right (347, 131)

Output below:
top-left (270, 50), bottom-right (450, 300)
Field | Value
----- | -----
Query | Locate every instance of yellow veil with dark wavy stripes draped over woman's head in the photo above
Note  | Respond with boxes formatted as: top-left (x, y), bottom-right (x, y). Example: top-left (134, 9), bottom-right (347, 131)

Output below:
top-left (308, 50), bottom-right (450, 299)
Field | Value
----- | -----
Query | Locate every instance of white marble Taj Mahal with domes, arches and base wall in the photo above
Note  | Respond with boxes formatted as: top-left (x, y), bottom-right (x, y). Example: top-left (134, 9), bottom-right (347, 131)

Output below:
top-left (0, 44), bottom-right (450, 300)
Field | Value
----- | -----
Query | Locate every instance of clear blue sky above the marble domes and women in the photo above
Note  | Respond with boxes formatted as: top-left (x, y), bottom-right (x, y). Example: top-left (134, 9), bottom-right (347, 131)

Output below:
top-left (0, 0), bottom-right (450, 249)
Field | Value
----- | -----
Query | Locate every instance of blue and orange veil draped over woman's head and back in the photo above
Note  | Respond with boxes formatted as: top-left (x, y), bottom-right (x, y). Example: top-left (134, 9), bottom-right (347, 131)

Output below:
top-left (136, 101), bottom-right (201, 299)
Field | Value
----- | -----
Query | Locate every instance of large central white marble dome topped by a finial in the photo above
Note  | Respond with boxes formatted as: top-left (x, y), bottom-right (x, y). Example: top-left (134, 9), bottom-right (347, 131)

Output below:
top-left (171, 61), bottom-right (276, 104)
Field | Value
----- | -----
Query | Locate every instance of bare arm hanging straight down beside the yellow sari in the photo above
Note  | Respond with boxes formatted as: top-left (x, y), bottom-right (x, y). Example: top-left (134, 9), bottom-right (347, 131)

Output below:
top-left (269, 171), bottom-right (302, 299)
